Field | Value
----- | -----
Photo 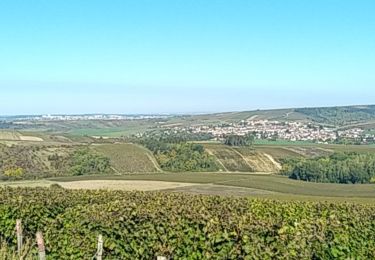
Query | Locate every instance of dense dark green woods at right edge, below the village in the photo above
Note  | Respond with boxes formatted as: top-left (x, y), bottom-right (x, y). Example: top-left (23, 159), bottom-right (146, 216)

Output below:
top-left (282, 152), bottom-right (375, 184)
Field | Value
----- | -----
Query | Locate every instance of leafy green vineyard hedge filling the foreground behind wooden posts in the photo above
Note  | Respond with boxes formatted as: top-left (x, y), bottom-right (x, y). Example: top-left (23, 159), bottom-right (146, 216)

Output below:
top-left (0, 187), bottom-right (375, 259)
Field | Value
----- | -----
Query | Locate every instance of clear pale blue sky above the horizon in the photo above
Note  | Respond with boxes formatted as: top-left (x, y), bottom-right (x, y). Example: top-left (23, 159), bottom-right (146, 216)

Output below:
top-left (0, 0), bottom-right (375, 114)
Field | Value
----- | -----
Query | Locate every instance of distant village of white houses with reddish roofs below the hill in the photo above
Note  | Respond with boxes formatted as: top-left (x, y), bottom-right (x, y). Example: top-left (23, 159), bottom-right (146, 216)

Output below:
top-left (164, 120), bottom-right (375, 143)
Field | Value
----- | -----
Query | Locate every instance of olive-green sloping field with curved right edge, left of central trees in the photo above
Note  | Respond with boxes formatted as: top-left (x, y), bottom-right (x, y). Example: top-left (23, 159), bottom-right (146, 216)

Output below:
top-left (92, 144), bottom-right (160, 173)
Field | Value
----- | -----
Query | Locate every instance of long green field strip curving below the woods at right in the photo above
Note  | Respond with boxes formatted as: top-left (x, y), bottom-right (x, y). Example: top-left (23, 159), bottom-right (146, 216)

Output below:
top-left (49, 173), bottom-right (375, 201)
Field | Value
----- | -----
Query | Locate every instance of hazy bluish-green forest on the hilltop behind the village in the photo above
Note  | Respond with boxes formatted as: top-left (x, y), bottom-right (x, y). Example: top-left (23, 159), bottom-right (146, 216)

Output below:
top-left (295, 105), bottom-right (375, 126)
